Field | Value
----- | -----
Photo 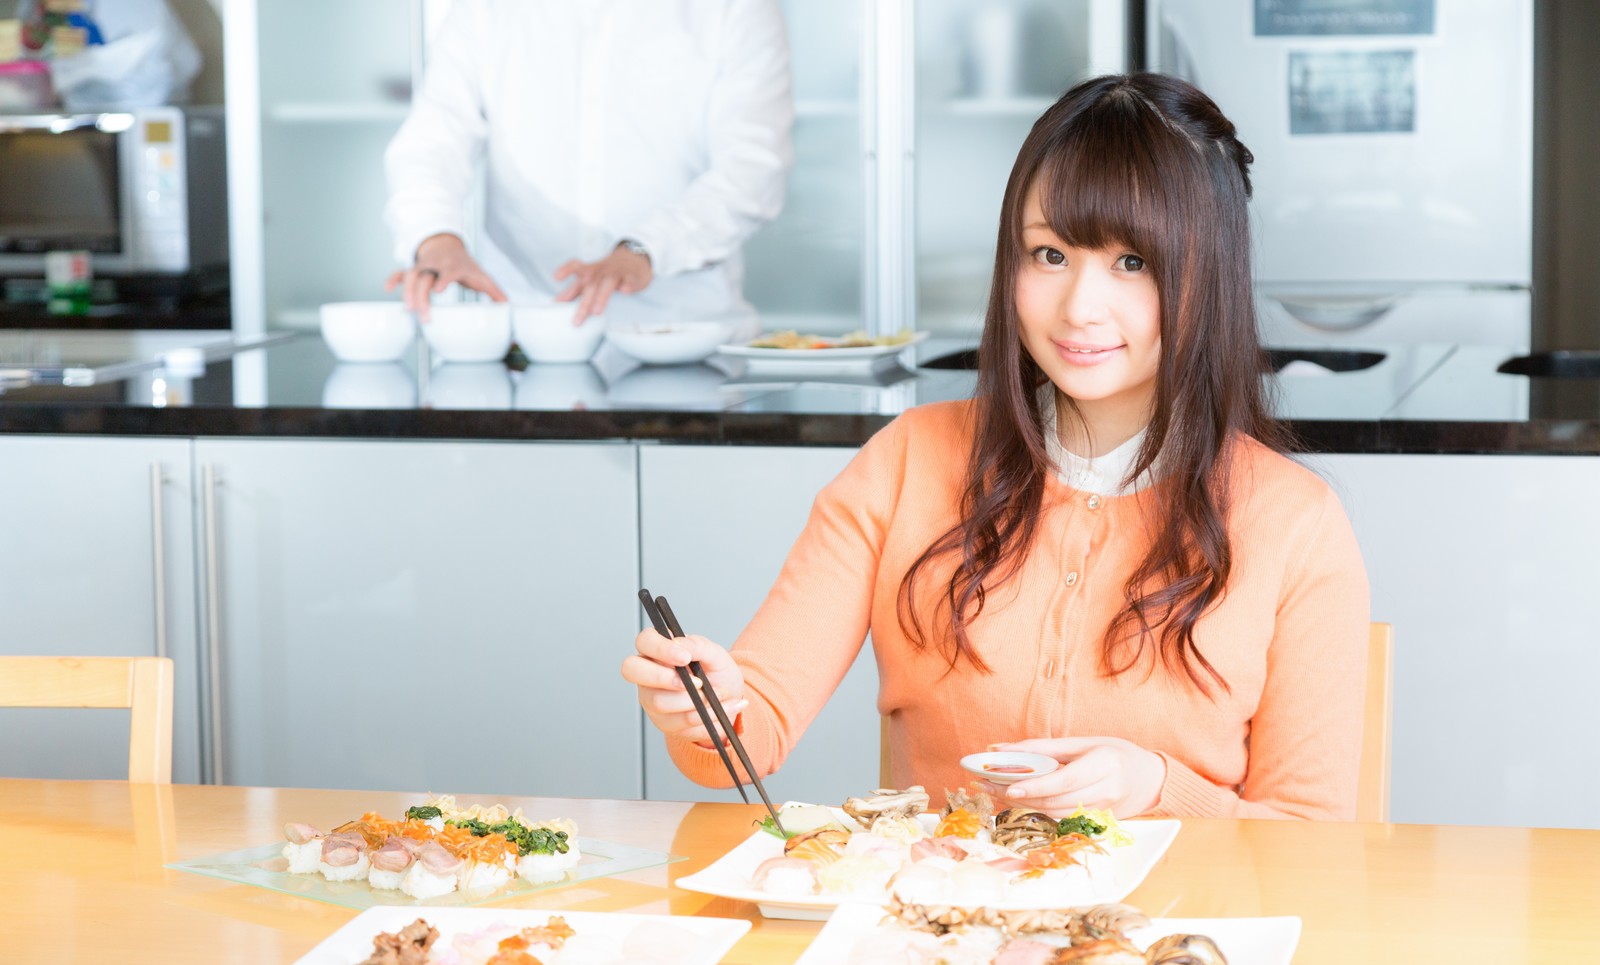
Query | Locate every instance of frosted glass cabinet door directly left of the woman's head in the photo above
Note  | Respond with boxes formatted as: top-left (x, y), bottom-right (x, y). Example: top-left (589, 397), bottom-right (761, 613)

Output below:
top-left (915, 0), bottom-right (1126, 336)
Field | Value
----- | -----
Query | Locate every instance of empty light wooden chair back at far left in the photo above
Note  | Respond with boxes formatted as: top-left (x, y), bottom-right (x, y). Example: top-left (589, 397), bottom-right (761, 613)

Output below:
top-left (0, 656), bottom-right (173, 784)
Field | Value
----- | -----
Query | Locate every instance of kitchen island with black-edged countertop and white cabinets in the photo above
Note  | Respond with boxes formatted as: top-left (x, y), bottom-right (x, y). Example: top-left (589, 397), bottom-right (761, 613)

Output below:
top-left (0, 329), bottom-right (1600, 827)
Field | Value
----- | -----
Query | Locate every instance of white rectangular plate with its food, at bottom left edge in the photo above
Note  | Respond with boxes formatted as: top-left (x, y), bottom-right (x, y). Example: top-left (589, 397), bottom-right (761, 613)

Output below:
top-left (296, 907), bottom-right (750, 965)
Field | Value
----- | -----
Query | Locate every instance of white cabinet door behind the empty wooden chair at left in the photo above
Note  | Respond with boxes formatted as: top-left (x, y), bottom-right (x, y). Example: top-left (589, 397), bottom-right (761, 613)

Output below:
top-left (0, 435), bottom-right (198, 783)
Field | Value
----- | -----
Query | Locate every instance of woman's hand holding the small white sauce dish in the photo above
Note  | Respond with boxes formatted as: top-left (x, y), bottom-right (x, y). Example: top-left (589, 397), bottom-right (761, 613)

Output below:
top-left (986, 738), bottom-right (1166, 818)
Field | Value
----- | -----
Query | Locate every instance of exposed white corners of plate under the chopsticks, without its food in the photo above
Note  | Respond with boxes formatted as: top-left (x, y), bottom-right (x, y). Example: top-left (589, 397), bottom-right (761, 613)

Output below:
top-left (677, 805), bottom-right (1179, 922)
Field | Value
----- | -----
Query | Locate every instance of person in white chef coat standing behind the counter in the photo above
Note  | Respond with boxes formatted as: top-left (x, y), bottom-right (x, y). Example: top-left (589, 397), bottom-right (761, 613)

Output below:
top-left (386, 0), bottom-right (794, 332)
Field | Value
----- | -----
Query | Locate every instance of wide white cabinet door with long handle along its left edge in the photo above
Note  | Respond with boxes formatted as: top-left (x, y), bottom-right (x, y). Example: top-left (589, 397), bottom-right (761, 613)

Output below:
top-left (195, 440), bottom-right (642, 799)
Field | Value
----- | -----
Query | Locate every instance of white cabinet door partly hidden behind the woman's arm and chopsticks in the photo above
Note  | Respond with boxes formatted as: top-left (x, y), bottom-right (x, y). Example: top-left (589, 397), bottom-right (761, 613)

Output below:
top-left (635, 446), bottom-right (878, 803)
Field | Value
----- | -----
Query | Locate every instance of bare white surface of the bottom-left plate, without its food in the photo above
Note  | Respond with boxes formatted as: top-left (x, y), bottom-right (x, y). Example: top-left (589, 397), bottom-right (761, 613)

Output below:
top-left (296, 906), bottom-right (750, 965)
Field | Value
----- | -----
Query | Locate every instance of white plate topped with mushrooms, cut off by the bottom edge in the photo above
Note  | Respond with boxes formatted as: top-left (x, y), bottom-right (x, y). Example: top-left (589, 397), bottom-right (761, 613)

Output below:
top-left (795, 903), bottom-right (1301, 965)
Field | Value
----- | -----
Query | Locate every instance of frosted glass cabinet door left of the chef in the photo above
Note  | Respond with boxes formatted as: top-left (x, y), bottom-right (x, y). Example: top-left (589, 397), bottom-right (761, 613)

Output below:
top-left (226, 0), bottom-right (422, 330)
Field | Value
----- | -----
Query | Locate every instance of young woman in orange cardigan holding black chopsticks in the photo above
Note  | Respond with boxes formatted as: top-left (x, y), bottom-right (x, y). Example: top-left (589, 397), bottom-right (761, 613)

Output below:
top-left (622, 74), bottom-right (1368, 819)
